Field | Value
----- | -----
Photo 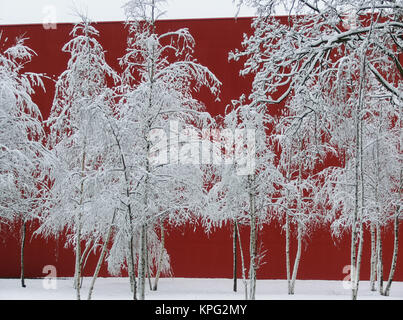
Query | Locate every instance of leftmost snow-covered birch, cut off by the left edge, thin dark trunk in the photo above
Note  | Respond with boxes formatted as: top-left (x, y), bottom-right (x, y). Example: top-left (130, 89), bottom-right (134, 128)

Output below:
top-left (0, 33), bottom-right (49, 287)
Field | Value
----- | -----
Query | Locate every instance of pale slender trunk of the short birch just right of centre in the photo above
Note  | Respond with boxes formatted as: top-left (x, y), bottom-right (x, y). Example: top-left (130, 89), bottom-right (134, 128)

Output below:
top-left (249, 175), bottom-right (257, 300)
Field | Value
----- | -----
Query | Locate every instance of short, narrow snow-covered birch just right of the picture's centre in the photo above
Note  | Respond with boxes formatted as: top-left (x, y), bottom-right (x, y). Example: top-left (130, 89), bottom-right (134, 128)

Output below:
top-left (208, 97), bottom-right (281, 300)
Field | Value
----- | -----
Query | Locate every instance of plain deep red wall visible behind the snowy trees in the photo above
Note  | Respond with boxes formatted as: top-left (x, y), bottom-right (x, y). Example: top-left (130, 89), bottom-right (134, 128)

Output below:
top-left (0, 18), bottom-right (403, 281)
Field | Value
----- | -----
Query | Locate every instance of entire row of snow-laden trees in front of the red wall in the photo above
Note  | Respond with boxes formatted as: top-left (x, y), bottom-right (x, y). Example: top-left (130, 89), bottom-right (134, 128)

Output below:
top-left (0, 0), bottom-right (403, 300)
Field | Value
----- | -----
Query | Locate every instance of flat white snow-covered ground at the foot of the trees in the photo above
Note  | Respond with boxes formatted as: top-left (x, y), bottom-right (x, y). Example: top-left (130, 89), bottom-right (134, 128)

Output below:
top-left (0, 278), bottom-right (403, 300)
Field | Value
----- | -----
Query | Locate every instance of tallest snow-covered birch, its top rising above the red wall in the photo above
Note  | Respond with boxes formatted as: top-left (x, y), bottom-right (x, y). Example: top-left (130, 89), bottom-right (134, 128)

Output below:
top-left (110, 0), bottom-right (220, 300)
